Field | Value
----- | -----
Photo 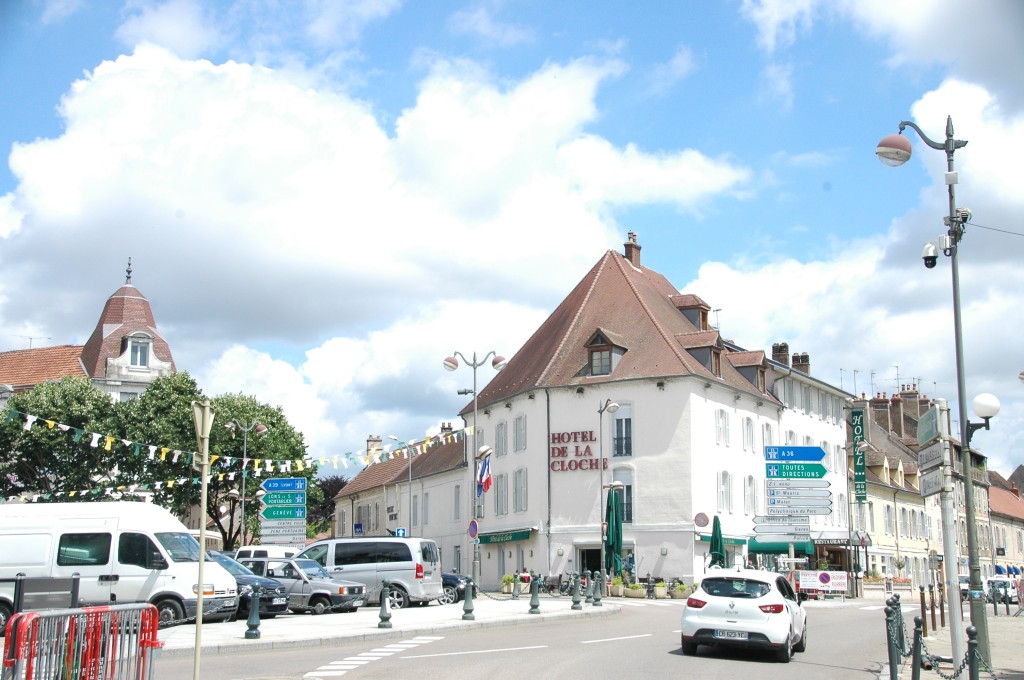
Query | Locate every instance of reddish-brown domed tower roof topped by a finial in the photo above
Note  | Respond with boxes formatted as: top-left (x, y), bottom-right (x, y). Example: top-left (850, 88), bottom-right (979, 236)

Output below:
top-left (82, 284), bottom-right (174, 378)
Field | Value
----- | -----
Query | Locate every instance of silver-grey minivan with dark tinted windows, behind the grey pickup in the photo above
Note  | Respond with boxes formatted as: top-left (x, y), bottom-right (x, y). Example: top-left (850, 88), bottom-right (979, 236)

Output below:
top-left (297, 537), bottom-right (444, 609)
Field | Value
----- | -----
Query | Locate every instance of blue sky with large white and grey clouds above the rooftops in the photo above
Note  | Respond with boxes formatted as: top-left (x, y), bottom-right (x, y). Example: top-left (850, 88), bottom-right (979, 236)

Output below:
top-left (0, 0), bottom-right (1024, 474)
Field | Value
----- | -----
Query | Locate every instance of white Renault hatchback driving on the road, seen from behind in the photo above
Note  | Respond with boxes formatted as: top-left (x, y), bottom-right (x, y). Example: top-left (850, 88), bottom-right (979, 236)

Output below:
top-left (681, 568), bottom-right (807, 664)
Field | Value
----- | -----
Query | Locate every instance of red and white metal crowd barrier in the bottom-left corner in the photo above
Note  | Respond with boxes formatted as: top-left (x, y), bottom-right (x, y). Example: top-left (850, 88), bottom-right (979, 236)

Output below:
top-left (0, 604), bottom-right (163, 680)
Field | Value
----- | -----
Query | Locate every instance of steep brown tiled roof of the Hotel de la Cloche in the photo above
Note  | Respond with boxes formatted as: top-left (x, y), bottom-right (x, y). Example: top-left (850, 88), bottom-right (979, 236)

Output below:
top-left (463, 246), bottom-right (775, 414)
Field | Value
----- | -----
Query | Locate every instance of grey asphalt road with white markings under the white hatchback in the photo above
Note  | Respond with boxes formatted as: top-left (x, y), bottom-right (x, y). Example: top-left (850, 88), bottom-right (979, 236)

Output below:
top-left (155, 604), bottom-right (886, 680)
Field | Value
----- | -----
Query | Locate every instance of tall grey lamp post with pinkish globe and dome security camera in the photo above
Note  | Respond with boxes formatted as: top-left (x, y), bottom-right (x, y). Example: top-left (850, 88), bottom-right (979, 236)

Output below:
top-left (876, 116), bottom-right (998, 662)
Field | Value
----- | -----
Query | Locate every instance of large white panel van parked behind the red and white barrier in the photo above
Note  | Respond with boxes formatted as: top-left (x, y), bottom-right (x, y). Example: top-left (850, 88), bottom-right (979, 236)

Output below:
top-left (0, 502), bottom-right (239, 626)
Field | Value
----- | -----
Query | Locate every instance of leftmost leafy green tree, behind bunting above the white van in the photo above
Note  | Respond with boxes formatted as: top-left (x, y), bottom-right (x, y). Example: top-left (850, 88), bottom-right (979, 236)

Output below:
top-left (0, 377), bottom-right (119, 502)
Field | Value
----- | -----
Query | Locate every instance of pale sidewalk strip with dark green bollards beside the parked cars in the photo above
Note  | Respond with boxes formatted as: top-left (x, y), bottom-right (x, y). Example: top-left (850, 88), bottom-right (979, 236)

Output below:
top-left (152, 593), bottom-right (621, 656)
